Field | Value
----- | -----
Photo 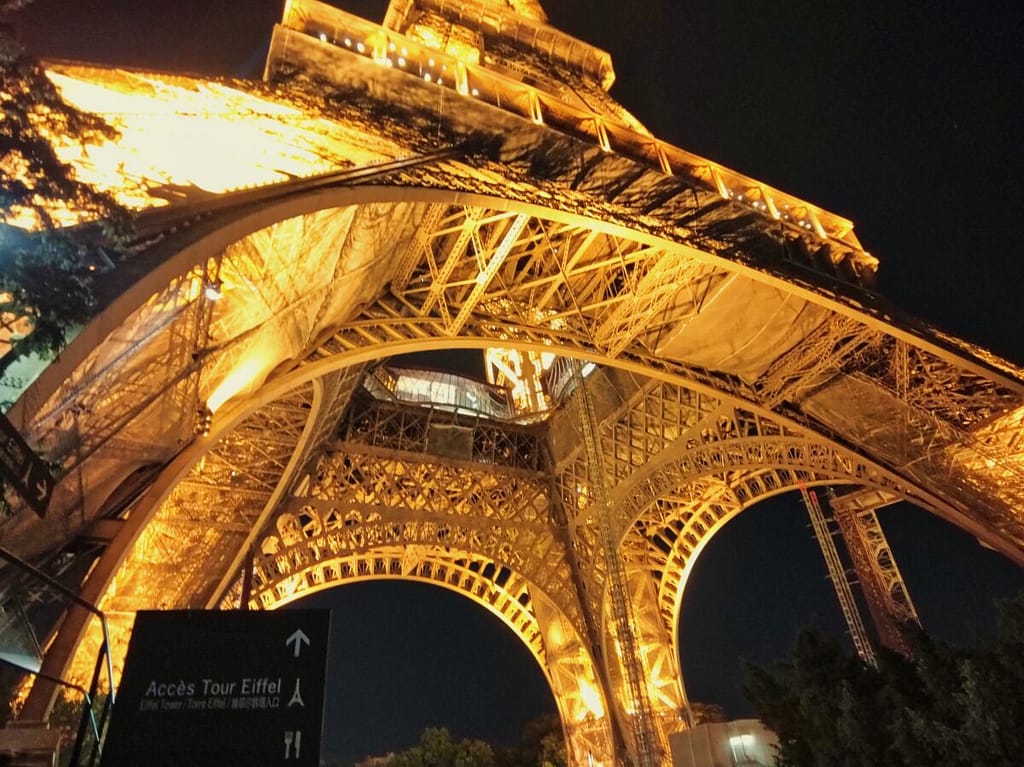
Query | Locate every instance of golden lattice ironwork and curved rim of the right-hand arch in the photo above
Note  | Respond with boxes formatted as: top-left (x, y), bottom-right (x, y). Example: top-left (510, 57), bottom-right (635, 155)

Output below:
top-left (585, 382), bottom-right (937, 647)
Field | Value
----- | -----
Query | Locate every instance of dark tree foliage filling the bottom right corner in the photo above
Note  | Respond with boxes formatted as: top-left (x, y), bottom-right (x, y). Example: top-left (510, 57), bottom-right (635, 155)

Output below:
top-left (745, 596), bottom-right (1024, 767)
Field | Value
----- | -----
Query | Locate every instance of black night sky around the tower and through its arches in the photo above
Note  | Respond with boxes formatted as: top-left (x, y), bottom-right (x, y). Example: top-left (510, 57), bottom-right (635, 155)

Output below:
top-left (14, 0), bottom-right (1024, 761)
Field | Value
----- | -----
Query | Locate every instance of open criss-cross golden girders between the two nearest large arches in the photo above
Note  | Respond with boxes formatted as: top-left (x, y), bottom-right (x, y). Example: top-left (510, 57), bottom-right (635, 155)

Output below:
top-left (392, 197), bottom-right (737, 356)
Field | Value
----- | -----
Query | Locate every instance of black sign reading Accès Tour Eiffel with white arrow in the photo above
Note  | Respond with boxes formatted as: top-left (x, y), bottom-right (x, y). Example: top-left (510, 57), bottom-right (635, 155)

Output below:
top-left (101, 610), bottom-right (331, 767)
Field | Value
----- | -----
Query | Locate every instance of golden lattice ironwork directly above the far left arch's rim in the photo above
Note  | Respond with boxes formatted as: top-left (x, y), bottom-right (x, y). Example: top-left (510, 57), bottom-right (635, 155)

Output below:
top-left (259, 442), bottom-right (579, 621)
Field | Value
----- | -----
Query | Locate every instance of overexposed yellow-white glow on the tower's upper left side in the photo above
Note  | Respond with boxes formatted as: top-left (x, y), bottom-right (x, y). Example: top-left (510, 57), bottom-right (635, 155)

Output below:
top-left (14, 66), bottom-right (397, 228)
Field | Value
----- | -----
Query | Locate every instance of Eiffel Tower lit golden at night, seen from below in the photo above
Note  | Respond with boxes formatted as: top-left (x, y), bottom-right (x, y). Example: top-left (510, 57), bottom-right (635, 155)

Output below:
top-left (0, 0), bottom-right (1024, 766)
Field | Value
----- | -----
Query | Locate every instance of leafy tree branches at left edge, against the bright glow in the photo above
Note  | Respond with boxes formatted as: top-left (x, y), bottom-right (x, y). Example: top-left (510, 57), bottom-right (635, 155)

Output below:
top-left (0, 0), bottom-right (129, 375)
